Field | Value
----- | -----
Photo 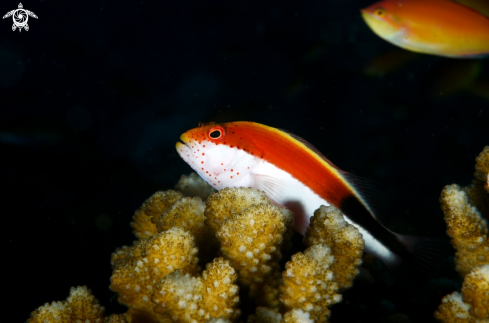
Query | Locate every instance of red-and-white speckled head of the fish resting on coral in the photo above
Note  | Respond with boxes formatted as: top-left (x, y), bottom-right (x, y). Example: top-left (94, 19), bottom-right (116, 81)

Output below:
top-left (176, 123), bottom-right (259, 190)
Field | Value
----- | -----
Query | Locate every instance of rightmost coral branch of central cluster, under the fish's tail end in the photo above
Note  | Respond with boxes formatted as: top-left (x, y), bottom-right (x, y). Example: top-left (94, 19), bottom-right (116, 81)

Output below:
top-left (304, 205), bottom-right (365, 291)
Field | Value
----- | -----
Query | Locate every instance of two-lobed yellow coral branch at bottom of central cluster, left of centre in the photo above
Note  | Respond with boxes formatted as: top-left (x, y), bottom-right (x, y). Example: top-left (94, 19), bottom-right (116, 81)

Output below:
top-left (153, 258), bottom-right (240, 323)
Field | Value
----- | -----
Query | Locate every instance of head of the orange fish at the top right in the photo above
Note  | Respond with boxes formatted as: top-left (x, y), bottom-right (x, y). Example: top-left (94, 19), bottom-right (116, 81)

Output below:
top-left (361, 0), bottom-right (404, 40)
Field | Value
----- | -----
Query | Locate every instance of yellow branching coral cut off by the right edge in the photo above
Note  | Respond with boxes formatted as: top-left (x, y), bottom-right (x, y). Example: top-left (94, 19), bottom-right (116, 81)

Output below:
top-left (435, 147), bottom-right (489, 323)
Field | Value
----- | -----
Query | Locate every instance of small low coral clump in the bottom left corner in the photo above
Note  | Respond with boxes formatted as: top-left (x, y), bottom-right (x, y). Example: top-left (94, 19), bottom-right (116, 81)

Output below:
top-left (27, 286), bottom-right (126, 323)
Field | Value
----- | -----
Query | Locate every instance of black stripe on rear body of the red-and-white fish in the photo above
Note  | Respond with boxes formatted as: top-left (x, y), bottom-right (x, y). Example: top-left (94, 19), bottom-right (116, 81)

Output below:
top-left (339, 195), bottom-right (410, 258)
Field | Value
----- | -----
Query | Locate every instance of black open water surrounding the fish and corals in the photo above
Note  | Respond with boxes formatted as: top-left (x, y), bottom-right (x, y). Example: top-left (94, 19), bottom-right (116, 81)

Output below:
top-left (0, 0), bottom-right (489, 322)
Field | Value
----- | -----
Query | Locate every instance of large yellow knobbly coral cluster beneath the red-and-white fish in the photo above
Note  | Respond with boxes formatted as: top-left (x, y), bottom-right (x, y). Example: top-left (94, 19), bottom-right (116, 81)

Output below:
top-left (25, 175), bottom-right (364, 323)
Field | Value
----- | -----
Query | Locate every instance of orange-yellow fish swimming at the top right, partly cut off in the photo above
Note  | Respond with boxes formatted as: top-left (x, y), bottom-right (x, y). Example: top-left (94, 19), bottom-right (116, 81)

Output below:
top-left (361, 0), bottom-right (489, 58)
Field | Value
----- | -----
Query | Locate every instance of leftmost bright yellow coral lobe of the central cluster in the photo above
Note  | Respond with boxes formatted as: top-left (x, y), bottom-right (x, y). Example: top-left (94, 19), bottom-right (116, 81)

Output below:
top-left (110, 228), bottom-right (198, 320)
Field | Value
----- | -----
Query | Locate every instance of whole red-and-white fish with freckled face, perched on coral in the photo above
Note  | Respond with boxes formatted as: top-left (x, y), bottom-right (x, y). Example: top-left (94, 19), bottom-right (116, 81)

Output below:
top-left (176, 121), bottom-right (438, 268)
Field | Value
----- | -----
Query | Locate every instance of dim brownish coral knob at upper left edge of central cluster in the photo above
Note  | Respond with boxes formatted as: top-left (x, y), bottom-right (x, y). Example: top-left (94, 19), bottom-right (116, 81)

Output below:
top-left (131, 190), bottom-right (182, 239)
